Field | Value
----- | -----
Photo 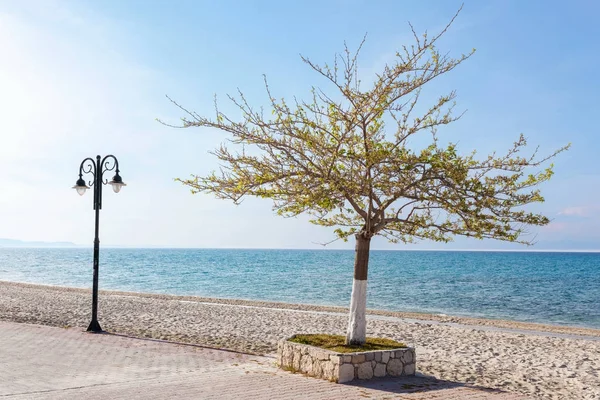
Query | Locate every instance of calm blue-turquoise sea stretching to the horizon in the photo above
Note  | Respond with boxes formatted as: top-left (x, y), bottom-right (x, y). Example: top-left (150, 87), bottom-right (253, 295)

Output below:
top-left (0, 248), bottom-right (600, 328)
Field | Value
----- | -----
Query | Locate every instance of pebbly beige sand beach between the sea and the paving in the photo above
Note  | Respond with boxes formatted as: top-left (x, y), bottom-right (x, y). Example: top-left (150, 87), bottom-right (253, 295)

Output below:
top-left (0, 282), bottom-right (600, 399)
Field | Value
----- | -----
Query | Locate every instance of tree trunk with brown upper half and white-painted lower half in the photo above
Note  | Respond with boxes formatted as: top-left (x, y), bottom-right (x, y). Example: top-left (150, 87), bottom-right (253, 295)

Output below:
top-left (346, 233), bottom-right (371, 345)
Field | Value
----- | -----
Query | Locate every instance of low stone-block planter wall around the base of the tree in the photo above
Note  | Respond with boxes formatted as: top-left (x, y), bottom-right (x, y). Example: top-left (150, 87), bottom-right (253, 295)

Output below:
top-left (277, 336), bottom-right (416, 383)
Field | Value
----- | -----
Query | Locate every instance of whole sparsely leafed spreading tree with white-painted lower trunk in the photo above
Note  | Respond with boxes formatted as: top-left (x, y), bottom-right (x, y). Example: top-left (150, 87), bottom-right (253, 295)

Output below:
top-left (164, 10), bottom-right (568, 344)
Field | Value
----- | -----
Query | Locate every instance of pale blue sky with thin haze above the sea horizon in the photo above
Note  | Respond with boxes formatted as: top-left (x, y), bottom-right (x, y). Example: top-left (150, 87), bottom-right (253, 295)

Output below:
top-left (0, 0), bottom-right (600, 250)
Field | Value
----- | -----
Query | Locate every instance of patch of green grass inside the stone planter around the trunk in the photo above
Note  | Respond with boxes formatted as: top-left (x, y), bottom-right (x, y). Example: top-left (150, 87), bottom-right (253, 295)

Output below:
top-left (289, 334), bottom-right (406, 353)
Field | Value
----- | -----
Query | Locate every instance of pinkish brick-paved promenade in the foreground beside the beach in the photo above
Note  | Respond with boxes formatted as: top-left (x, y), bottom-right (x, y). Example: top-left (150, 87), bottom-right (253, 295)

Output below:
top-left (0, 321), bottom-right (524, 400)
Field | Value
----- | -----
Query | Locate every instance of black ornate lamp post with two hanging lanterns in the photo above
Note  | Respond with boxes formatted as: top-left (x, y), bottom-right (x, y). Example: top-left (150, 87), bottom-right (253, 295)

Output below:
top-left (73, 155), bottom-right (126, 333)
